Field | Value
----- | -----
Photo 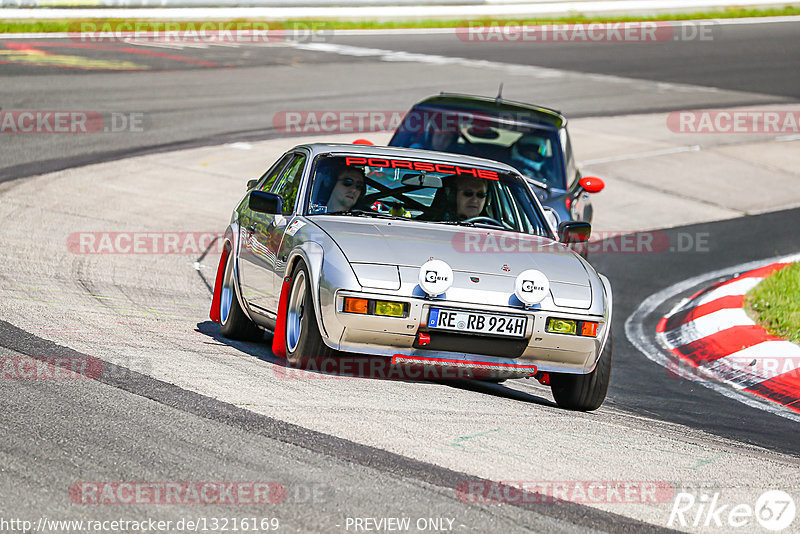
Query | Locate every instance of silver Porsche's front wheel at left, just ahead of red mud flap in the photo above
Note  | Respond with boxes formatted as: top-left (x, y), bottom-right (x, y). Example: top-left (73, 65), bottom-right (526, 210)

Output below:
top-left (285, 262), bottom-right (336, 366)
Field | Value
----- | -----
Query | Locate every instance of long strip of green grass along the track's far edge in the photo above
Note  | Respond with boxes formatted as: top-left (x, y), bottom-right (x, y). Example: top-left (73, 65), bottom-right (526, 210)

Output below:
top-left (0, 6), bottom-right (800, 33)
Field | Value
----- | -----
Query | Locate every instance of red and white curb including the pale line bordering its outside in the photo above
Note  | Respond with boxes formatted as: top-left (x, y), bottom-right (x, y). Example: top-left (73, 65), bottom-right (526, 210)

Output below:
top-left (625, 254), bottom-right (800, 421)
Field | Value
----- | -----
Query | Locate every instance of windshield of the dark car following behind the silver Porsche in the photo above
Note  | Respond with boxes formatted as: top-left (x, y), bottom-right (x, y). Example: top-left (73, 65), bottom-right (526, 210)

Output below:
top-left (389, 109), bottom-right (565, 189)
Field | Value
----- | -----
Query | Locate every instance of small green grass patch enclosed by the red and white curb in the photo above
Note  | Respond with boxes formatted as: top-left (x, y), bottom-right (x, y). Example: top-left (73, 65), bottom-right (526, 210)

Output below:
top-left (745, 263), bottom-right (800, 343)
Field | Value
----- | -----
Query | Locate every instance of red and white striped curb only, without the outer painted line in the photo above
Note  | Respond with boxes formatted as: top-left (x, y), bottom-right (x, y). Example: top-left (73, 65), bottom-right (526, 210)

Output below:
top-left (656, 262), bottom-right (800, 413)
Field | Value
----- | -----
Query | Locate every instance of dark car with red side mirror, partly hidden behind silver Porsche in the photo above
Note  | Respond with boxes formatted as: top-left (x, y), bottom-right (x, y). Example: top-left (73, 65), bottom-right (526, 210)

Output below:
top-left (389, 93), bottom-right (604, 236)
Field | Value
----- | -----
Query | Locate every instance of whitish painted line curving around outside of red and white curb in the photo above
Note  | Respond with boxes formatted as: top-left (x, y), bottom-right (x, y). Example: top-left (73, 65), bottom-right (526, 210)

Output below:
top-left (625, 254), bottom-right (800, 422)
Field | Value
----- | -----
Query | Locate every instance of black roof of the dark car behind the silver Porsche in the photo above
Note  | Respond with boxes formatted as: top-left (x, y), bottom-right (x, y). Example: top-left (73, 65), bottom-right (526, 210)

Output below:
top-left (414, 93), bottom-right (567, 128)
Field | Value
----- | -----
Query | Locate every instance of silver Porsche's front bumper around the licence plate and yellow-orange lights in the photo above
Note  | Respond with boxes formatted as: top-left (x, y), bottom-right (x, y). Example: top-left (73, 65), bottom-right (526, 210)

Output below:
top-left (329, 291), bottom-right (607, 378)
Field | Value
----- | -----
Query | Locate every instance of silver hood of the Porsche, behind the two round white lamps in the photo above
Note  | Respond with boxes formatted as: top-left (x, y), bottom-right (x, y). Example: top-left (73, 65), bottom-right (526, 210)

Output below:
top-left (313, 215), bottom-right (591, 308)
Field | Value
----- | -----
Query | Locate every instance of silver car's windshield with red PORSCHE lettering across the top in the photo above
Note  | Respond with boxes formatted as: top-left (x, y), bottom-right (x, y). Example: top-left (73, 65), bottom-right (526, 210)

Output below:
top-left (306, 155), bottom-right (551, 237)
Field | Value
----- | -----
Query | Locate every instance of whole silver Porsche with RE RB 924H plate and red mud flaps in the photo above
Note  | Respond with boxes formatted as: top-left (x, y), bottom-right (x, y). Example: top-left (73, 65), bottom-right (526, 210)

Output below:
top-left (211, 144), bottom-right (612, 410)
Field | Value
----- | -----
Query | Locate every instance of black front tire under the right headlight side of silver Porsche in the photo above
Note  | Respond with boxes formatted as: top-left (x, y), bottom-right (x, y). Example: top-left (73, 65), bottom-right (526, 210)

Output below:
top-left (550, 333), bottom-right (614, 412)
